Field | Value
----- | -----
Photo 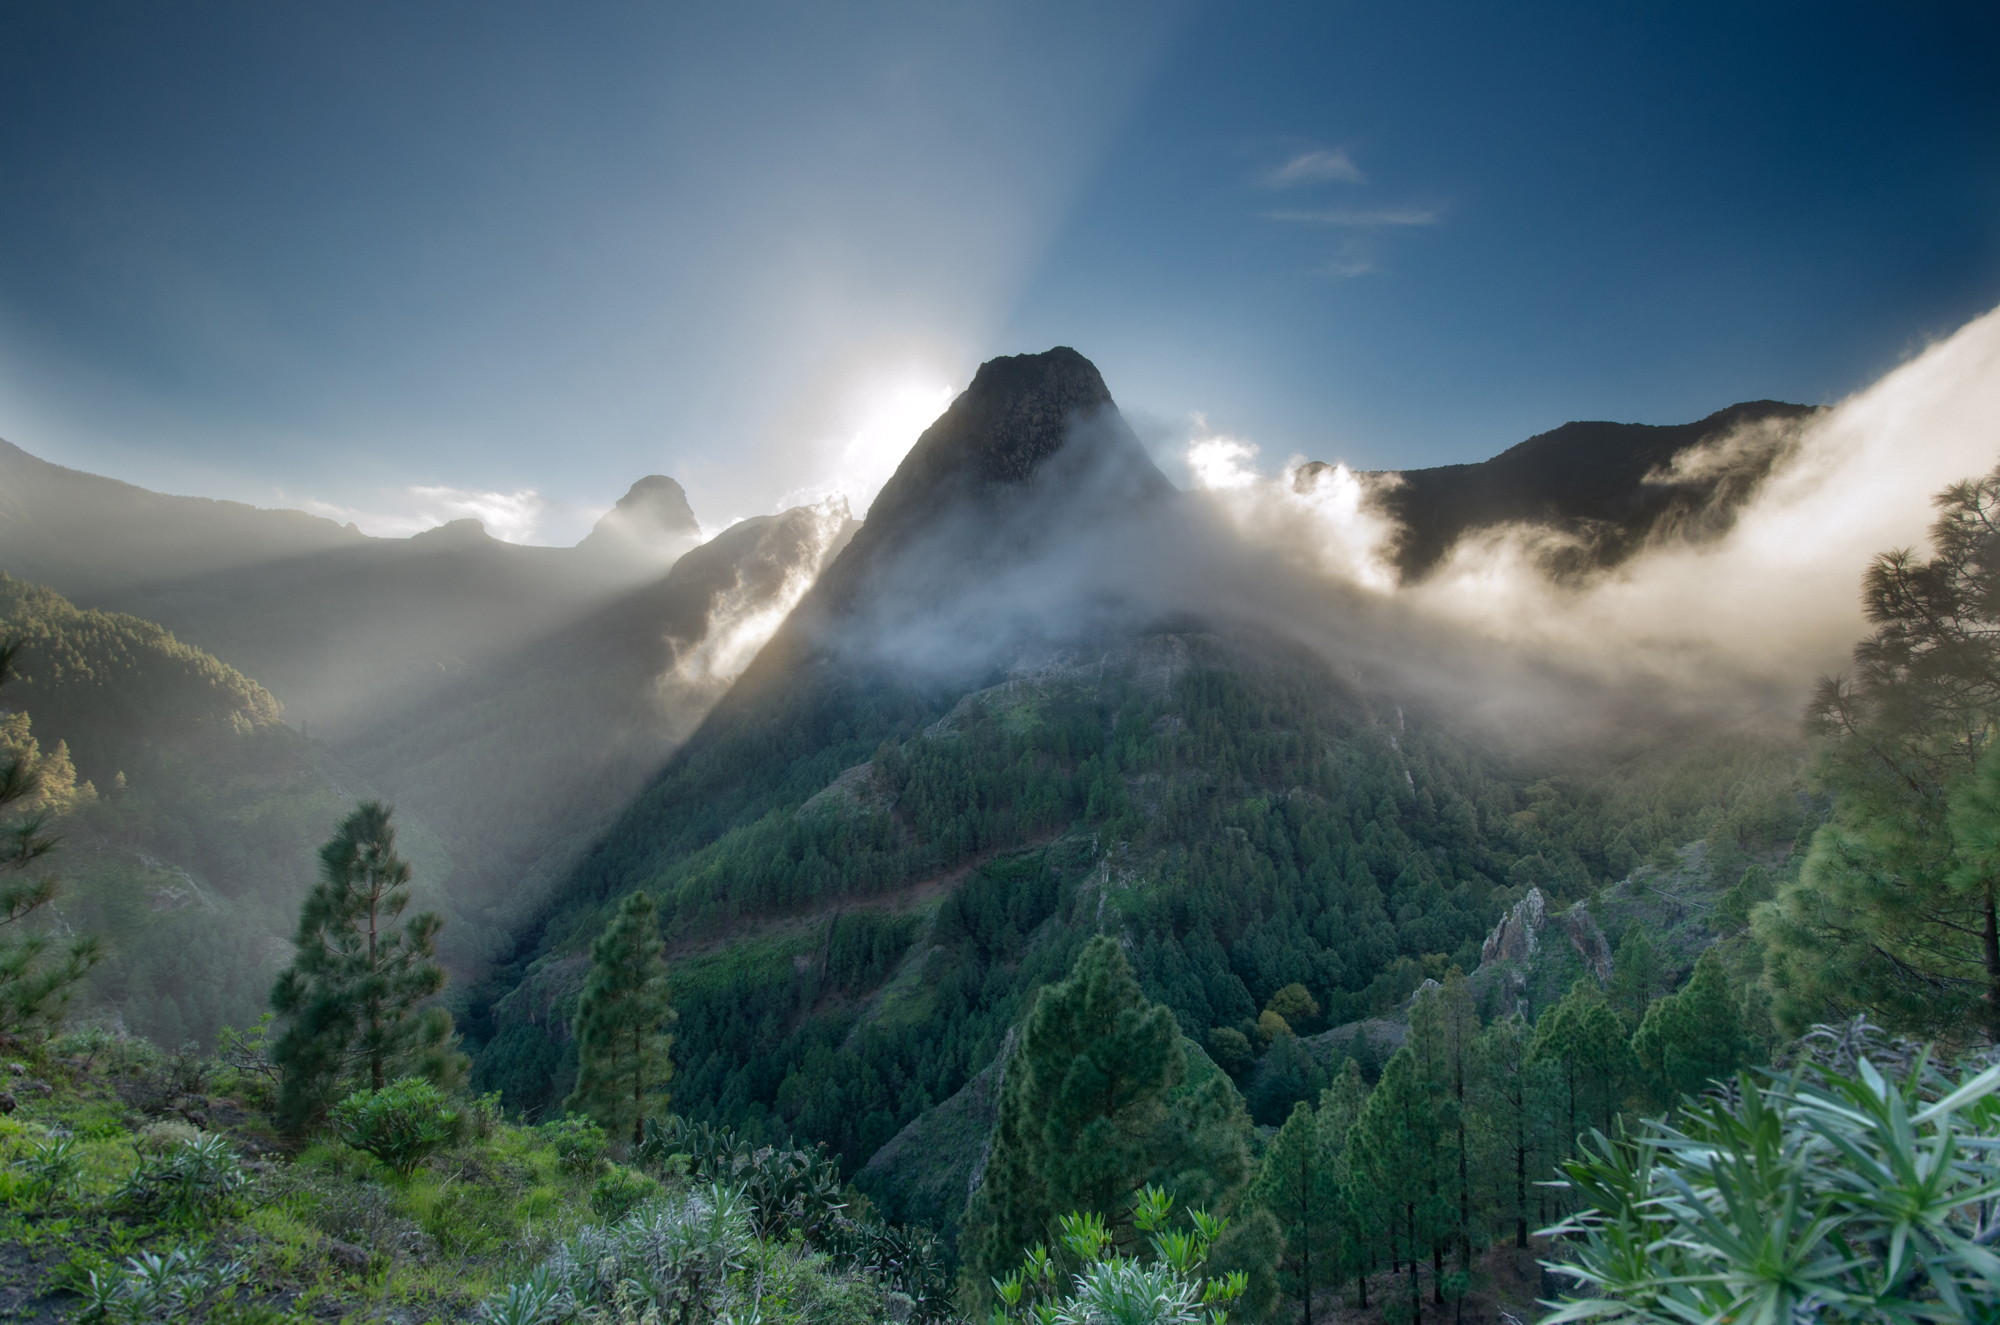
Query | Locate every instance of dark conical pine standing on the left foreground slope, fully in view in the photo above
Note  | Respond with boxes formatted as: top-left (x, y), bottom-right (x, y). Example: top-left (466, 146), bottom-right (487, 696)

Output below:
top-left (270, 801), bottom-right (466, 1129)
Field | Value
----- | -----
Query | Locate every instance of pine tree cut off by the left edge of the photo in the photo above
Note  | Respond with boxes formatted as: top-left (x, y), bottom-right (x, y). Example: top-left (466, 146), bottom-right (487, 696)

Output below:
top-left (0, 642), bottom-right (104, 1035)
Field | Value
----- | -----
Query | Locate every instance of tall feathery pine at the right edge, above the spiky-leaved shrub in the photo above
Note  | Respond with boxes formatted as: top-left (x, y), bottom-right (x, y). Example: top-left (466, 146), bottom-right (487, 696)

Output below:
top-left (1756, 472), bottom-right (2000, 1037)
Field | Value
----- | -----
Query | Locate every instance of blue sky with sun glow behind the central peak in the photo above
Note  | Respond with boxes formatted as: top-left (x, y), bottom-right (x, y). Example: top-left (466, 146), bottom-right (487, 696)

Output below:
top-left (0, 0), bottom-right (2000, 542)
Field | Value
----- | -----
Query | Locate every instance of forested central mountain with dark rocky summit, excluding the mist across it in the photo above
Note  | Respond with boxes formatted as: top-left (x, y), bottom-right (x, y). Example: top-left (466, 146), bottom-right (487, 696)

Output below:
top-left (466, 350), bottom-right (1800, 1211)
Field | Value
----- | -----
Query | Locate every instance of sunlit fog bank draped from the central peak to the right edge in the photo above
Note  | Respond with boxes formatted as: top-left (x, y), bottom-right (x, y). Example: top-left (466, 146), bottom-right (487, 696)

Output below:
top-left (716, 312), bottom-right (2000, 756)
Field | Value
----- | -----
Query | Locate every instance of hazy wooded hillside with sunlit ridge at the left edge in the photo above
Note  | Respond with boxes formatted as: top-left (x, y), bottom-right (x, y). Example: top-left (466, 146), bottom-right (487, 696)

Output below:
top-left (0, 572), bottom-right (412, 1045)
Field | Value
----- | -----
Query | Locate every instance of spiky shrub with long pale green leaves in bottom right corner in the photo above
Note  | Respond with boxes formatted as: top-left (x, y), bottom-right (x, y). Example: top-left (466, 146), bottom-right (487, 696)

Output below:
top-left (1548, 1059), bottom-right (2000, 1325)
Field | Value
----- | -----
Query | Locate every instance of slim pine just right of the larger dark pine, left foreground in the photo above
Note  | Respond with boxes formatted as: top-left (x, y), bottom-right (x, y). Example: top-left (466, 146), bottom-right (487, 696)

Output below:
top-left (562, 893), bottom-right (676, 1145)
